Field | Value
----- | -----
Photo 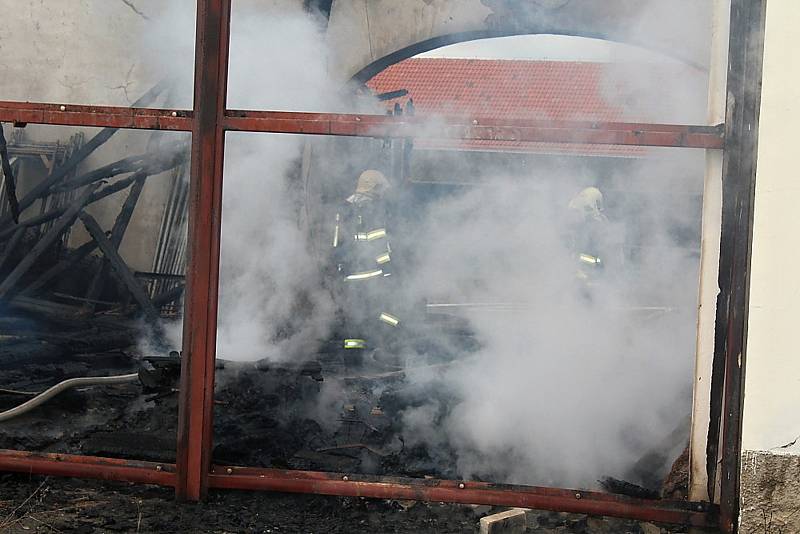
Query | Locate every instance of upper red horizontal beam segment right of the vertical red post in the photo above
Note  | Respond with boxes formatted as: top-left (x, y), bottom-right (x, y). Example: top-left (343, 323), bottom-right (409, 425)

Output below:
top-left (224, 110), bottom-right (724, 149)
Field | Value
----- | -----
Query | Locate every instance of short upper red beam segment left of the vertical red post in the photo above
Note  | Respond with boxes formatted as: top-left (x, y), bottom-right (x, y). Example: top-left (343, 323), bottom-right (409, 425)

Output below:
top-left (0, 101), bottom-right (193, 132)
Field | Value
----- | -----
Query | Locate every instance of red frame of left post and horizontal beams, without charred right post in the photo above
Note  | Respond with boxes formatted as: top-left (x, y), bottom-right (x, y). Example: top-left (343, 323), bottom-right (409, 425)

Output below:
top-left (0, 0), bottom-right (764, 526)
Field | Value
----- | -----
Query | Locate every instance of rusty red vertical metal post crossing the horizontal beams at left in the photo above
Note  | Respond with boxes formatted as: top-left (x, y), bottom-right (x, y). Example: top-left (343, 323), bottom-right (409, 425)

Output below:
top-left (175, 0), bottom-right (231, 500)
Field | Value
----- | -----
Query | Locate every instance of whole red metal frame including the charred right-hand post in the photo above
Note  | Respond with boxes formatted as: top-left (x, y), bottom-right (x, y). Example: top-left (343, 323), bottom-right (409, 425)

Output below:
top-left (0, 0), bottom-right (766, 532)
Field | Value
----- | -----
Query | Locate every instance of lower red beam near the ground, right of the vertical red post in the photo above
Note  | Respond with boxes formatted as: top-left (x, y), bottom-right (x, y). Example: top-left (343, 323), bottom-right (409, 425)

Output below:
top-left (209, 466), bottom-right (717, 527)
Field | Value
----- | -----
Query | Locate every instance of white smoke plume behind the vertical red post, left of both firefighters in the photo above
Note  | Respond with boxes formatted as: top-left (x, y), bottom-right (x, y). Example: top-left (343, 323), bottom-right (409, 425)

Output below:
top-left (145, 1), bottom-right (356, 361)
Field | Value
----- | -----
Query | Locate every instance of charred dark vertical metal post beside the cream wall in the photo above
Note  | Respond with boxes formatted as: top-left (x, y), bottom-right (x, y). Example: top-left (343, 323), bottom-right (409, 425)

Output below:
top-left (708, 0), bottom-right (766, 533)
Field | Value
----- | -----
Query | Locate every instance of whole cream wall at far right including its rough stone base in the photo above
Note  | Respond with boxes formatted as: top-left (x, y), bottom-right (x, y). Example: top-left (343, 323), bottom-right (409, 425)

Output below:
top-left (741, 0), bottom-right (800, 533)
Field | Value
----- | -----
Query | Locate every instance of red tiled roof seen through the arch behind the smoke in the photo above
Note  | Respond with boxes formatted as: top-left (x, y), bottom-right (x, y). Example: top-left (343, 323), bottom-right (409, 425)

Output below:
top-left (367, 58), bottom-right (645, 157)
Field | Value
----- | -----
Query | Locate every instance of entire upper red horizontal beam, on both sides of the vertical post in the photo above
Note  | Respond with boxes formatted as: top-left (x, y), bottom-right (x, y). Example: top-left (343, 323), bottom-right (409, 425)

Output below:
top-left (0, 101), bottom-right (724, 149)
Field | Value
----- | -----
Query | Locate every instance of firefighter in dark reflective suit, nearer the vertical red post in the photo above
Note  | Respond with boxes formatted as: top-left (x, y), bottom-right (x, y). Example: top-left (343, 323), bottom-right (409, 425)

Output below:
top-left (332, 169), bottom-right (402, 361)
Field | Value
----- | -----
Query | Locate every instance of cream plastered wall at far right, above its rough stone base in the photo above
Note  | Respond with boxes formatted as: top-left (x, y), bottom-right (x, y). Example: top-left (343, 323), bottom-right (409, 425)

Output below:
top-left (742, 0), bottom-right (800, 452)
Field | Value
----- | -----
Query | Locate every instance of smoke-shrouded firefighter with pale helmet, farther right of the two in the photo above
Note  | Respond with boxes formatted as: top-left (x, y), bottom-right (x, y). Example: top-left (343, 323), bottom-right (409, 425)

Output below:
top-left (569, 187), bottom-right (608, 280)
